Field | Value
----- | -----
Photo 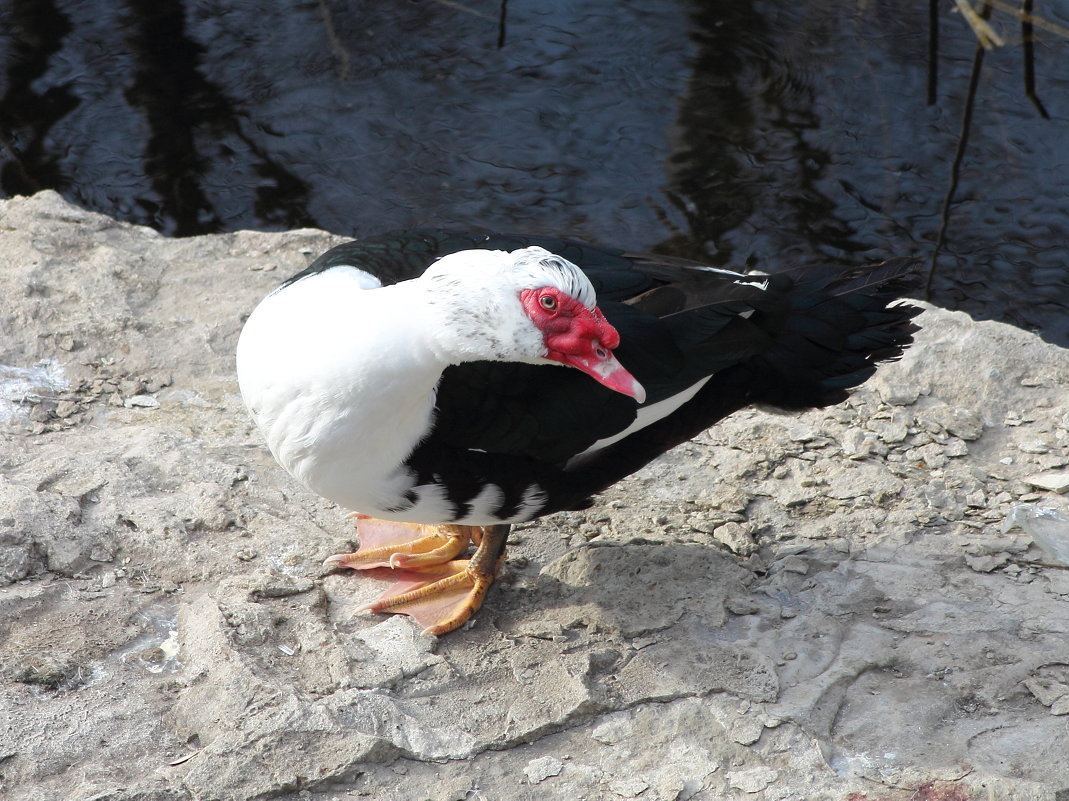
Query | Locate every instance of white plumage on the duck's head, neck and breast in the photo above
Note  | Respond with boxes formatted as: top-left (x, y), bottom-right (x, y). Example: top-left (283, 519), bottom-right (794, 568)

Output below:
top-left (237, 248), bottom-right (594, 525)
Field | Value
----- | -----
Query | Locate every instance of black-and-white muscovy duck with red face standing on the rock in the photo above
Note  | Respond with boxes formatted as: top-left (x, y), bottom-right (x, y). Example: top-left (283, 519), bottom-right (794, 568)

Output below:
top-left (237, 230), bottom-right (919, 634)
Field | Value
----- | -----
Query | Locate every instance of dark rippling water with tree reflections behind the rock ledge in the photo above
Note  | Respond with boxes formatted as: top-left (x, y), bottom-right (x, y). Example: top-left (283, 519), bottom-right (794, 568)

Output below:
top-left (0, 0), bottom-right (1069, 345)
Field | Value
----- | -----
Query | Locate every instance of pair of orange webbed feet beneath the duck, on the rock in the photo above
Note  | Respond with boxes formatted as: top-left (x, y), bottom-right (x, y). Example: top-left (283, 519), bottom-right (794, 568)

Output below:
top-left (325, 519), bottom-right (509, 635)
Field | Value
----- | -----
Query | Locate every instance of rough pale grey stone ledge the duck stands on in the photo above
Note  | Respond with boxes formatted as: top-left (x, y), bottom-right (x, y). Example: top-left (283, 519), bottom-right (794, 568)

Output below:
top-left (0, 192), bottom-right (1069, 801)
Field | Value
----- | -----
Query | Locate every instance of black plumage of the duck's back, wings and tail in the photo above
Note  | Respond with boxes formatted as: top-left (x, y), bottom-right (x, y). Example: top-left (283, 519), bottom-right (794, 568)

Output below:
top-left (303, 230), bottom-right (919, 518)
